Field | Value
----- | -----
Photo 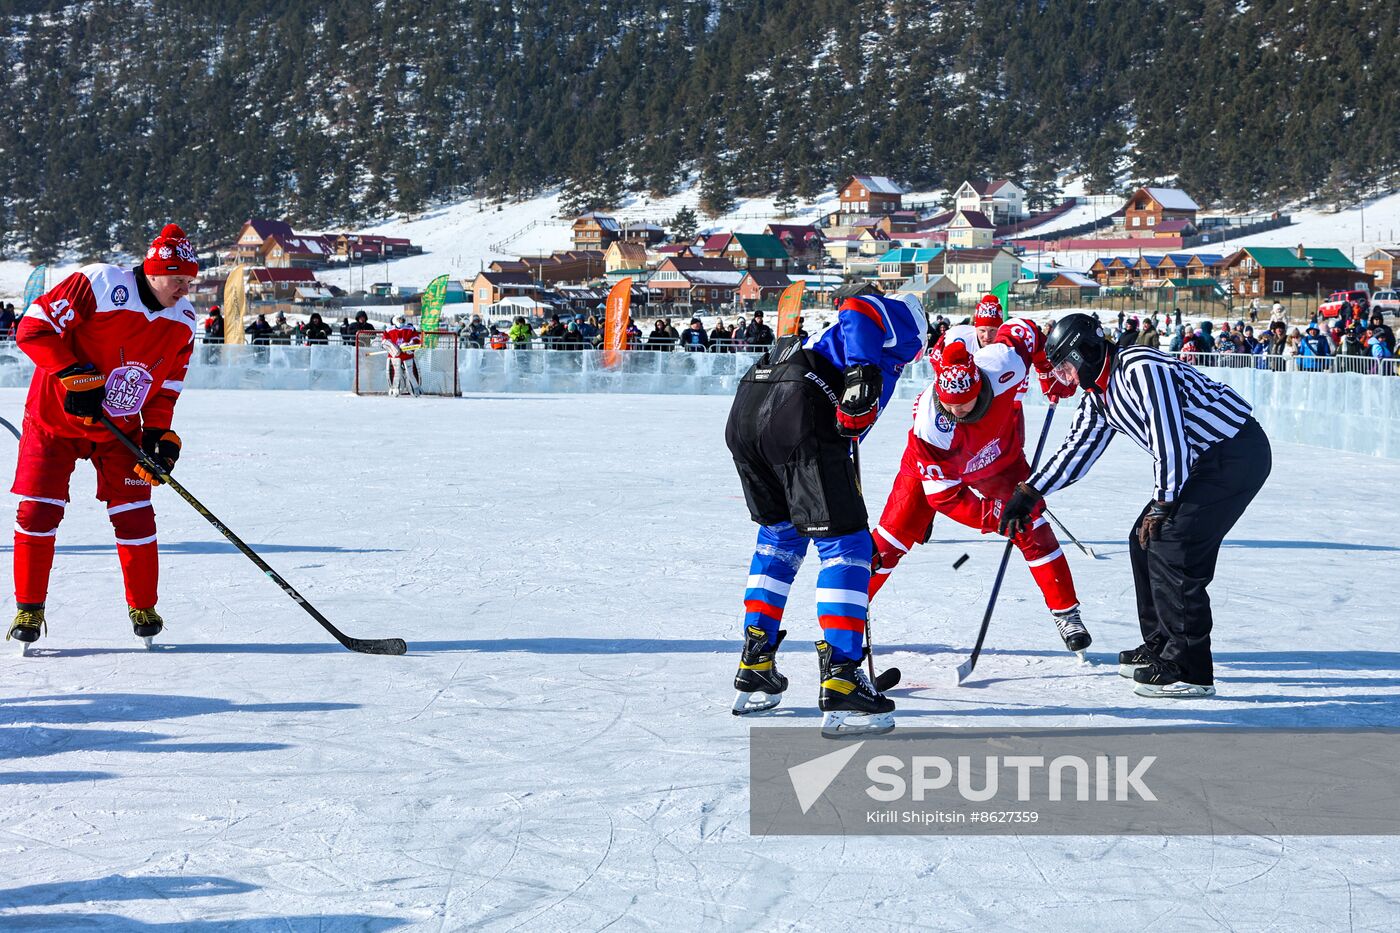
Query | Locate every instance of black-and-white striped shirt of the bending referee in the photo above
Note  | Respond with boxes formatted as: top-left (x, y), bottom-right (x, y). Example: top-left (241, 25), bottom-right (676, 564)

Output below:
top-left (1028, 346), bottom-right (1252, 502)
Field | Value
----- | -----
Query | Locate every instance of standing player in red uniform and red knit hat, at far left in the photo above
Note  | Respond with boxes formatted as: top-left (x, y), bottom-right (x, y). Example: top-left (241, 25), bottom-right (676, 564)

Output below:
top-left (7, 224), bottom-right (199, 644)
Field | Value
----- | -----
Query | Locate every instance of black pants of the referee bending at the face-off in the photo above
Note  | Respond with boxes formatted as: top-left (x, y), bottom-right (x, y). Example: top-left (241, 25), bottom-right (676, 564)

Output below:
top-left (1128, 417), bottom-right (1274, 684)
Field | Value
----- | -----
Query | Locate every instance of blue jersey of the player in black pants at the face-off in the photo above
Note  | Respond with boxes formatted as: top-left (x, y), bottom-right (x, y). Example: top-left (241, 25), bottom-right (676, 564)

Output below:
top-left (806, 294), bottom-right (928, 412)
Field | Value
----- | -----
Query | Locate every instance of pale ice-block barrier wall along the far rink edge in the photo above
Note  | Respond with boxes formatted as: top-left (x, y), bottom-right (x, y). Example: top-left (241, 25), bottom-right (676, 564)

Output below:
top-left (0, 345), bottom-right (1400, 459)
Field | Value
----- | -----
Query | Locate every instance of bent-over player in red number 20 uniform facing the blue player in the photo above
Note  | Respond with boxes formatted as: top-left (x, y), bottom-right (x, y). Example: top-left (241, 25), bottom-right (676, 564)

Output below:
top-left (869, 319), bottom-right (1091, 653)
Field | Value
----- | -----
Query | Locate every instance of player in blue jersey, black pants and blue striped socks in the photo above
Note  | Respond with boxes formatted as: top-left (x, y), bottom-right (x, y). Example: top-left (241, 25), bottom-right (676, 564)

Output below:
top-left (725, 286), bottom-right (928, 735)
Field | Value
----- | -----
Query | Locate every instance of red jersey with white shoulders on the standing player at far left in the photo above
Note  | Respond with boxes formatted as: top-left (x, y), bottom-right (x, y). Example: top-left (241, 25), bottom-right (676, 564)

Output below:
top-left (15, 263), bottom-right (197, 441)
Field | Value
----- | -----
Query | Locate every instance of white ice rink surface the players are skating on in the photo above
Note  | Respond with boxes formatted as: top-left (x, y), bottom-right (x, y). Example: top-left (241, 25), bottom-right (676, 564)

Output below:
top-left (0, 389), bottom-right (1400, 933)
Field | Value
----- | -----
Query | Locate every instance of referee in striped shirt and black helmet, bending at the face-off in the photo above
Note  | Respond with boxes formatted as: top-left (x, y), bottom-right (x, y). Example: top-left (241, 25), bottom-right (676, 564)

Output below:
top-left (1001, 314), bottom-right (1273, 696)
